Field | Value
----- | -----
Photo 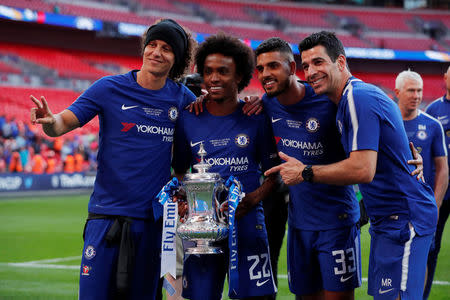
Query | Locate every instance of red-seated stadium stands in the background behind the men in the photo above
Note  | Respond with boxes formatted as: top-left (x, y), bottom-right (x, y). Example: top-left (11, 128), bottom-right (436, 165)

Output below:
top-left (0, 0), bottom-right (450, 175)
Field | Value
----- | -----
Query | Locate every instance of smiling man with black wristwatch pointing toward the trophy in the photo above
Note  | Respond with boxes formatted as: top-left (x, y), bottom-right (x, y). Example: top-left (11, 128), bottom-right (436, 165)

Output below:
top-left (266, 31), bottom-right (437, 299)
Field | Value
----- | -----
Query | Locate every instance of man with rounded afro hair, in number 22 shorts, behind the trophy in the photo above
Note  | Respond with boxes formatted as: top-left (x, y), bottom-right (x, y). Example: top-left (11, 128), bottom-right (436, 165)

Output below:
top-left (173, 33), bottom-right (278, 300)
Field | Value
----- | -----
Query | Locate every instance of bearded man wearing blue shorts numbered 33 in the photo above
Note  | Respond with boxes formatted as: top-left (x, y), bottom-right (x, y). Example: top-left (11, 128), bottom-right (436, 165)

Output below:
top-left (255, 38), bottom-right (361, 299)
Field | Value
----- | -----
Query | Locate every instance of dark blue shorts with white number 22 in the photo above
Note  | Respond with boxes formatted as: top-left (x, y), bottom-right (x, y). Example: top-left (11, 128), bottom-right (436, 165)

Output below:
top-left (183, 212), bottom-right (277, 300)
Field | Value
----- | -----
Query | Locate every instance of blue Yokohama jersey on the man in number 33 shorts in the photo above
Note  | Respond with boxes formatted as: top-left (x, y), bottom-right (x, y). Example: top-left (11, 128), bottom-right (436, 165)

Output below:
top-left (263, 83), bottom-right (359, 230)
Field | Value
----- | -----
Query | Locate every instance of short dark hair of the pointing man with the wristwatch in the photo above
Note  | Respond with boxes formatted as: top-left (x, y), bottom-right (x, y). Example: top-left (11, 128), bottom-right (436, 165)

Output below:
top-left (298, 31), bottom-right (345, 62)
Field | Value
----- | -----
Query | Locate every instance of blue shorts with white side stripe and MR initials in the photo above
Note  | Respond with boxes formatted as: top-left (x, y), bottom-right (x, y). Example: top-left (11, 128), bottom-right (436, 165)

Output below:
top-left (368, 223), bottom-right (433, 300)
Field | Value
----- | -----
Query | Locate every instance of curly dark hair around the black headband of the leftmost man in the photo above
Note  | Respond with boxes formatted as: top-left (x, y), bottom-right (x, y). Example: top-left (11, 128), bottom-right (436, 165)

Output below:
top-left (141, 19), bottom-right (197, 81)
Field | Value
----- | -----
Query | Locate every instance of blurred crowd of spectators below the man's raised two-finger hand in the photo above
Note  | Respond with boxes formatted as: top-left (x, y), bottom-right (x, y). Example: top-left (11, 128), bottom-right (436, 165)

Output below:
top-left (0, 116), bottom-right (98, 174)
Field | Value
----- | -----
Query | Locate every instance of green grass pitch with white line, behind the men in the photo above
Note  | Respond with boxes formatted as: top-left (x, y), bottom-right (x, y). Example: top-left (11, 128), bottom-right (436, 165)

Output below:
top-left (0, 195), bottom-right (450, 300)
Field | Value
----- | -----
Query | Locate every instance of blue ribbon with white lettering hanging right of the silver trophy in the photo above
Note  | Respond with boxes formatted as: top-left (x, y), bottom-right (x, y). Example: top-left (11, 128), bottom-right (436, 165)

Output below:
top-left (225, 176), bottom-right (245, 297)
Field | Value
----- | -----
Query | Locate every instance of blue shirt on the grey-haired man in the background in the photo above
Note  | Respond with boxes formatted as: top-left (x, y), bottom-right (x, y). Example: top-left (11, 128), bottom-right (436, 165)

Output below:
top-left (403, 110), bottom-right (447, 188)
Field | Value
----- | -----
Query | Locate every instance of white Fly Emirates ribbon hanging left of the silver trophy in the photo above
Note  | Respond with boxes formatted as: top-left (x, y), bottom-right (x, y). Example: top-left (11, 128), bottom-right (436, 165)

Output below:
top-left (156, 177), bottom-right (180, 278)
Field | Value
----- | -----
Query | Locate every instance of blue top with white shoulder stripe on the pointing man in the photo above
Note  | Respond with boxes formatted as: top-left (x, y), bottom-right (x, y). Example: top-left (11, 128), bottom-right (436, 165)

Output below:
top-left (336, 77), bottom-right (437, 235)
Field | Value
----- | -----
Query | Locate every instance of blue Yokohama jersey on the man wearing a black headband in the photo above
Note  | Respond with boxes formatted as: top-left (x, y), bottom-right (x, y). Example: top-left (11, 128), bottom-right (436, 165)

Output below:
top-left (68, 71), bottom-right (195, 218)
